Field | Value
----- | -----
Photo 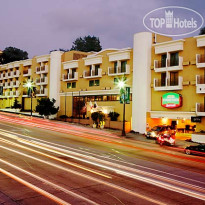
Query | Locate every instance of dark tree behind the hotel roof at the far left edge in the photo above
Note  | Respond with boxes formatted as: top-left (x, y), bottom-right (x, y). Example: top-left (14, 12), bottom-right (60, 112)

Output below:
top-left (0, 47), bottom-right (28, 64)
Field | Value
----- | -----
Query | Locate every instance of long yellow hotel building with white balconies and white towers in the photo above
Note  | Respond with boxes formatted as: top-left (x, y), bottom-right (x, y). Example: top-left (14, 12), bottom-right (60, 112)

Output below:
top-left (0, 32), bottom-right (205, 141)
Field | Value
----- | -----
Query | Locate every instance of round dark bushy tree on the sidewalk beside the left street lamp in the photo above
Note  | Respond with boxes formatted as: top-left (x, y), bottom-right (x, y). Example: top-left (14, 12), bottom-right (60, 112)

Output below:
top-left (36, 98), bottom-right (59, 117)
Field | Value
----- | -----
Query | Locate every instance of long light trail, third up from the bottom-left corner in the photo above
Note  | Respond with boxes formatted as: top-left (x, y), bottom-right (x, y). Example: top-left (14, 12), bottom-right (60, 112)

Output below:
top-left (0, 145), bottom-right (166, 205)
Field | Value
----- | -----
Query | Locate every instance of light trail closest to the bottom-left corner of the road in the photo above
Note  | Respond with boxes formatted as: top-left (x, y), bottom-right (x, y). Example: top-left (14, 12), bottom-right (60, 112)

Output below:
top-left (0, 168), bottom-right (71, 205)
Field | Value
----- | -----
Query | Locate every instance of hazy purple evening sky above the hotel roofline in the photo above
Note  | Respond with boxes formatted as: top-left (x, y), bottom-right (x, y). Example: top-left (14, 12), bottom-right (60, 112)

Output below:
top-left (0, 0), bottom-right (205, 58)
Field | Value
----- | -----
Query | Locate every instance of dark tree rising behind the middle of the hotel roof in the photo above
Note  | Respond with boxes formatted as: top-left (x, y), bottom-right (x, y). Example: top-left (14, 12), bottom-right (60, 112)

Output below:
top-left (70, 35), bottom-right (102, 52)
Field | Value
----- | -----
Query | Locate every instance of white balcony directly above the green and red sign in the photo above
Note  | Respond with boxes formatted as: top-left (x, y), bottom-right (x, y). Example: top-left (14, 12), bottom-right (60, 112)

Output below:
top-left (154, 76), bottom-right (183, 91)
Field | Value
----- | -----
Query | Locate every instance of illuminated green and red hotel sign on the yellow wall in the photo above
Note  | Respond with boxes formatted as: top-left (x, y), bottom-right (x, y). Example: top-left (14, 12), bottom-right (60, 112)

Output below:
top-left (161, 93), bottom-right (182, 108)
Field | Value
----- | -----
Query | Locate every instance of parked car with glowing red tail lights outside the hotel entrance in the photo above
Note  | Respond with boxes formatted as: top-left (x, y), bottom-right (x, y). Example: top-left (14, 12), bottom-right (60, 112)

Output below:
top-left (156, 130), bottom-right (175, 146)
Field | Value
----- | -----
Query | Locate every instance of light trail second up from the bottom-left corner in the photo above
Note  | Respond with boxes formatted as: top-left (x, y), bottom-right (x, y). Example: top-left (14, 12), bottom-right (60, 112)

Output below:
top-left (0, 159), bottom-right (98, 205)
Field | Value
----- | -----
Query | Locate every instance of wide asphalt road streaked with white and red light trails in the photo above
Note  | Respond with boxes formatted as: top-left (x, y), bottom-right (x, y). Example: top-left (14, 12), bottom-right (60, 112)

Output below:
top-left (0, 114), bottom-right (205, 205)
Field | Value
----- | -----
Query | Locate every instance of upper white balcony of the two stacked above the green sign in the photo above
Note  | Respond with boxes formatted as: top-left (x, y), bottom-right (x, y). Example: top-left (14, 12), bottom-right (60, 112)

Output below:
top-left (154, 56), bottom-right (183, 72)
